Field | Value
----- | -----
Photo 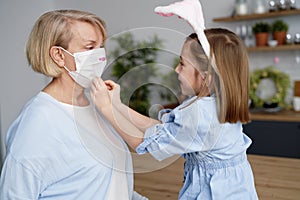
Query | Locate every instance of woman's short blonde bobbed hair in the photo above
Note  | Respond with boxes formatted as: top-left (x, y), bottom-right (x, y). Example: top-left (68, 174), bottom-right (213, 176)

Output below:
top-left (26, 10), bottom-right (106, 77)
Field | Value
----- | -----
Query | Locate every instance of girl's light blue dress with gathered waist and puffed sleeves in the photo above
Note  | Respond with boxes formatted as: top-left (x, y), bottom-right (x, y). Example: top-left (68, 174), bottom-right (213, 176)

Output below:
top-left (136, 96), bottom-right (258, 200)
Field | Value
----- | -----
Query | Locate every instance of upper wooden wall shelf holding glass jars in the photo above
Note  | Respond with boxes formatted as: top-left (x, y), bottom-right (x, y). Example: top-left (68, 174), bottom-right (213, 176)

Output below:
top-left (213, 9), bottom-right (300, 22)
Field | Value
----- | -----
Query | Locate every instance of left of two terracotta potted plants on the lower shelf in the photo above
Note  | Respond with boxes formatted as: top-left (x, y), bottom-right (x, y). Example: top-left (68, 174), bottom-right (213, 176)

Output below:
top-left (252, 22), bottom-right (270, 46)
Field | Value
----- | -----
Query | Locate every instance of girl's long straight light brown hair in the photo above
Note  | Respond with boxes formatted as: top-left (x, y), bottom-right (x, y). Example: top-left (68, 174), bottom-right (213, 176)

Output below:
top-left (186, 28), bottom-right (250, 123)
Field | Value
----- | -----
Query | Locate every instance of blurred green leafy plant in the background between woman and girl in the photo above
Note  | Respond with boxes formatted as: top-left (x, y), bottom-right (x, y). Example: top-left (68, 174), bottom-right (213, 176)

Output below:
top-left (110, 32), bottom-right (163, 115)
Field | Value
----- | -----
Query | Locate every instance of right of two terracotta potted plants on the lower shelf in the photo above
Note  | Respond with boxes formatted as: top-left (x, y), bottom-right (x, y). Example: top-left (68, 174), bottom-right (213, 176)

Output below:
top-left (271, 19), bottom-right (289, 45)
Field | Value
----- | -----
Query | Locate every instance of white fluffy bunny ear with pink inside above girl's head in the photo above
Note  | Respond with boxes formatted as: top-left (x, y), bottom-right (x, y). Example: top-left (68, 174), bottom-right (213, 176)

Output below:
top-left (154, 0), bottom-right (210, 58)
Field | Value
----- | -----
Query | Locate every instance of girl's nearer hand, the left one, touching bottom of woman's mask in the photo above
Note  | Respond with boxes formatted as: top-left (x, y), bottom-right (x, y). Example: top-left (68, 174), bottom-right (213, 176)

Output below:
top-left (90, 78), bottom-right (113, 111)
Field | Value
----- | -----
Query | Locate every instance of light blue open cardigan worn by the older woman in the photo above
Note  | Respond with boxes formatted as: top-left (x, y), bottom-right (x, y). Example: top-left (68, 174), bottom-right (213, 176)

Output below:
top-left (0, 92), bottom-right (143, 200)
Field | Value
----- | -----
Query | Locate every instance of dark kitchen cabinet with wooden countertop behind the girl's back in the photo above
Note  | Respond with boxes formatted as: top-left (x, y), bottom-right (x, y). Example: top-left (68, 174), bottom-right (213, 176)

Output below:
top-left (244, 110), bottom-right (300, 158)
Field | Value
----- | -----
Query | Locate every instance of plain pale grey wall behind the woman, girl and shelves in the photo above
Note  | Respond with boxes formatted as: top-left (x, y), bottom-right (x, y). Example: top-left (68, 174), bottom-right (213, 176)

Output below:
top-left (0, 0), bottom-right (300, 166)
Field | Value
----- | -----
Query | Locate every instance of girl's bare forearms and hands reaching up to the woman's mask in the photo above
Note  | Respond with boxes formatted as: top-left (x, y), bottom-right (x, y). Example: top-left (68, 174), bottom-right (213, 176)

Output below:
top-left (90, 78), bottom-right (158, 149)
